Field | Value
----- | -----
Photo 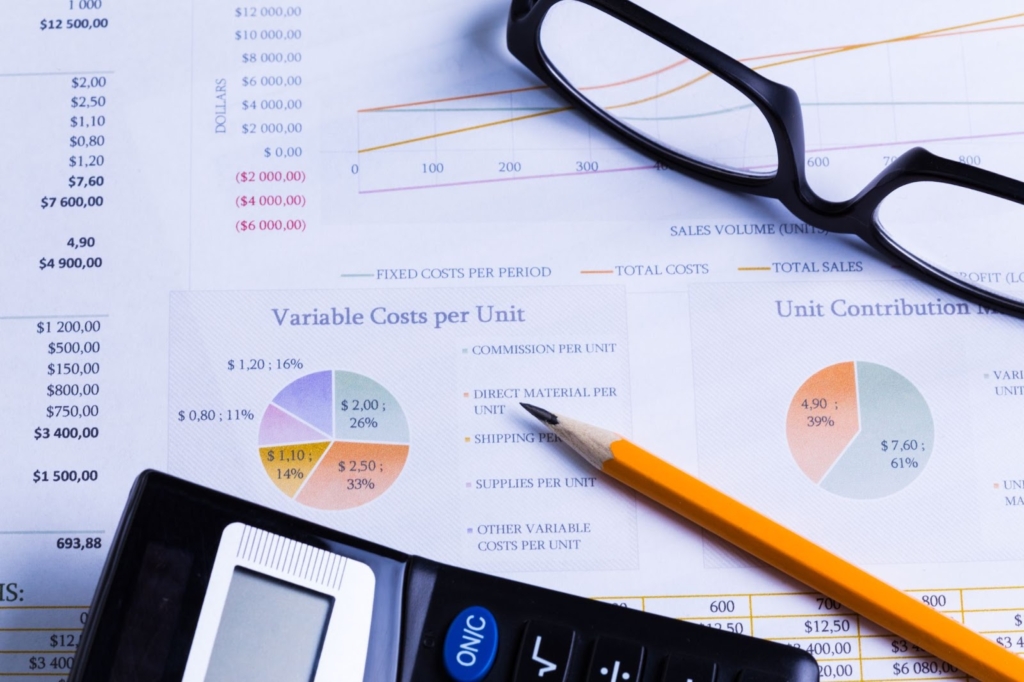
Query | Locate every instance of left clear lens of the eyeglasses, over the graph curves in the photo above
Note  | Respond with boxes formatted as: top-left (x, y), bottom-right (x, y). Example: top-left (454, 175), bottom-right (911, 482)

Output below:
top-left (541, 0), bottom-right (778, 177)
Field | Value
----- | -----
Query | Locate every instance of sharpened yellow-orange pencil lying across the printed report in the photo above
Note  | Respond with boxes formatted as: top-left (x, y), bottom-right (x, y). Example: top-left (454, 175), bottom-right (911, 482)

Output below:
top-left (520, 403), bottom-right (1024, 682)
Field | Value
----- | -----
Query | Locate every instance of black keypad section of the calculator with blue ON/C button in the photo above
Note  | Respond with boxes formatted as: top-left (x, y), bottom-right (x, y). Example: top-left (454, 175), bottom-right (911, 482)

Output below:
top-left (419, 559), bottom-right (818, 682)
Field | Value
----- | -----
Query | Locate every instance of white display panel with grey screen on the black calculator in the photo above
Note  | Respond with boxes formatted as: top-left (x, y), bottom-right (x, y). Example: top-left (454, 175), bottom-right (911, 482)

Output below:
top-left (182, 523), bottom-right (376, 682)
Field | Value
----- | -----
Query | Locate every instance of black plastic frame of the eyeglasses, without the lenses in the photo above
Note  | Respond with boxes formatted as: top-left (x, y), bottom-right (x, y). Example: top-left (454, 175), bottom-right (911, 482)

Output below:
top-left (507, 0), bottom-right (1024, 317)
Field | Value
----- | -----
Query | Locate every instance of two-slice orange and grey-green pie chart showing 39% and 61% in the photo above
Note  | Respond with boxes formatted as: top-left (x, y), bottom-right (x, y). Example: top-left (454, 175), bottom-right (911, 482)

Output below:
top-left (785, 360), bottom-right (935, 499)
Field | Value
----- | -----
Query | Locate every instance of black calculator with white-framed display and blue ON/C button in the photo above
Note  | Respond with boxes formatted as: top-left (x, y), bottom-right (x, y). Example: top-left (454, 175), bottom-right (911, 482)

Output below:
top-left (70, 471), bottom-right (818, 682)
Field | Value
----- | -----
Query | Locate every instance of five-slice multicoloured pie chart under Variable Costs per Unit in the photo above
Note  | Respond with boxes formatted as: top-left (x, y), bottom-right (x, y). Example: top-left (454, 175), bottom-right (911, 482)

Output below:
top-left (259, 371), bottom-right (409, 510)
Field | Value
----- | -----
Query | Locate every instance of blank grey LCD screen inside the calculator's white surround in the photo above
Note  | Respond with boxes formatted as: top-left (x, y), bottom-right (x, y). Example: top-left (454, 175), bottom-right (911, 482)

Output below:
top-left (206, 567), bottom-right (334, 682)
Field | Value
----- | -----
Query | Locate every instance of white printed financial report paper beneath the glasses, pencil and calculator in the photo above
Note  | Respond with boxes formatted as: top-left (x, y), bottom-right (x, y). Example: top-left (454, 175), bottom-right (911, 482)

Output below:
top-left (0, 0), bottom-right (1024, 681)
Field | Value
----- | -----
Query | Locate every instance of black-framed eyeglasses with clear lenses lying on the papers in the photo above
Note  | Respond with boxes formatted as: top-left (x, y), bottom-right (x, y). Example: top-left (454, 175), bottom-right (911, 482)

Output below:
top-left (508, 0), bottom-right (1024, 316)
